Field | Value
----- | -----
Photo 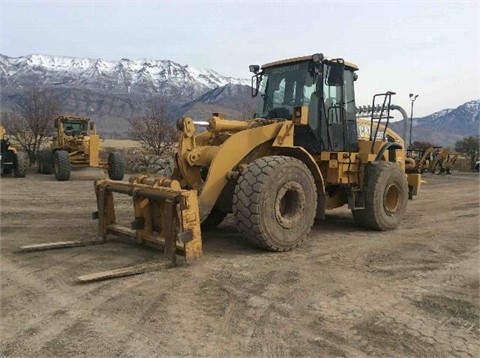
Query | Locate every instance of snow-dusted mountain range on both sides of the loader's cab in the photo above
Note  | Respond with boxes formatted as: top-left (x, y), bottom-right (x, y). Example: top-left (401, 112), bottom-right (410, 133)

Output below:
top-left (0, 54), bottom-right (480, 147)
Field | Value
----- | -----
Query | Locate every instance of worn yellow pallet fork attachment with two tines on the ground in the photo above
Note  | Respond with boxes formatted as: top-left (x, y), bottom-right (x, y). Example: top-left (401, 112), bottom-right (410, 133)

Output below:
top-left (20, 176), bottom-right (202, 282)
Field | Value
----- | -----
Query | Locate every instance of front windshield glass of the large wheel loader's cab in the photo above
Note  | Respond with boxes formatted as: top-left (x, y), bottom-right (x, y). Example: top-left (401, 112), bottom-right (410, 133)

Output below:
top-left (257, 62), bottom-right (315, 119)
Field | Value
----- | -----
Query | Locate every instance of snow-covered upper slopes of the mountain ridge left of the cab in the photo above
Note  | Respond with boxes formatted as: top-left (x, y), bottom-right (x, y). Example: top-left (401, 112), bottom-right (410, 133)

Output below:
top-left (0, 55), bottom-right (250, 103)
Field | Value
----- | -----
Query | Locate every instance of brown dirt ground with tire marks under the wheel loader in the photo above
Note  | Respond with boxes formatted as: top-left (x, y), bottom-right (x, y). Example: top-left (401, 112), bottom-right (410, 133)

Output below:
top-left (0, 172), bottom-right (480, 358)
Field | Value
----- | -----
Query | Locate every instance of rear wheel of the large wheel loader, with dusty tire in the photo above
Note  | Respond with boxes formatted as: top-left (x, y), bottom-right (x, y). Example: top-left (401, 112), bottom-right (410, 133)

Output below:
top-left (352, 162), bottom-right (409, 231)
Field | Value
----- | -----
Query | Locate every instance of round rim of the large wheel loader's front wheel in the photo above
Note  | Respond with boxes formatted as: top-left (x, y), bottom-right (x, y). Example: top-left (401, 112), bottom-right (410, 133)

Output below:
top-left (275, 181), bottom-right (305, 229)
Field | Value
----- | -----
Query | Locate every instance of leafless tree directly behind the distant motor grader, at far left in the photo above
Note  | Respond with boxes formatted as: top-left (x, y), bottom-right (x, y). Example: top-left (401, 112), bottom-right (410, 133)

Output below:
top-left (2, 86), bottom-right (60, 164)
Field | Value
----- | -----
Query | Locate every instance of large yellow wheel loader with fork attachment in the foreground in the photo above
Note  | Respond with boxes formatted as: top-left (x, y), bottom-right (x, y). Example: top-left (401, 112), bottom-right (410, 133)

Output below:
top-left (20, 54), bottom-right (421, 281)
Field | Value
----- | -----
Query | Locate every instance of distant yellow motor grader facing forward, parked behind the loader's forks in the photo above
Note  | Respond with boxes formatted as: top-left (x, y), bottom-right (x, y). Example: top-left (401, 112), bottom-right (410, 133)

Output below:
top-left (37, 115), bottom-right (124, 181)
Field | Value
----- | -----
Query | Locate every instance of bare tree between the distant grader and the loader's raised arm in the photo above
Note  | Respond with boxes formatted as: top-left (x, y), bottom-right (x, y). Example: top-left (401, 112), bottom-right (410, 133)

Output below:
top-left (128, 98), bottom-right (178, 156)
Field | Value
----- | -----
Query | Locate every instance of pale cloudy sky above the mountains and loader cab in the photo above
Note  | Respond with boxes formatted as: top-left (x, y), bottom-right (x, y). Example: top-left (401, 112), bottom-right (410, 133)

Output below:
top-left (0, 0), bottom-right (480, 117)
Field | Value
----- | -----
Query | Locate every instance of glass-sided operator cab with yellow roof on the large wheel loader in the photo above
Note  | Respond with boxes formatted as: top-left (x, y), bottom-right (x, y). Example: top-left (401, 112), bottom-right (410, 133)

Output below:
top-left (250, 54), bottom-right (358, 154)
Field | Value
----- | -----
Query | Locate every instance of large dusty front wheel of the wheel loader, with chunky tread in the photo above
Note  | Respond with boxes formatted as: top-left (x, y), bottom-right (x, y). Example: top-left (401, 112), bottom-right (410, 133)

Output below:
top-left (232, 156), bottom-right (317, 251)
